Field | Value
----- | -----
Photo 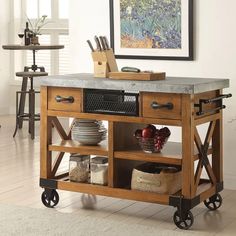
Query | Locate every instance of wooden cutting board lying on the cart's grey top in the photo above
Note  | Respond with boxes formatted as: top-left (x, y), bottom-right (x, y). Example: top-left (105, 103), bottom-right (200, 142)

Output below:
top-left (109, 72), bottom-right (166, 80)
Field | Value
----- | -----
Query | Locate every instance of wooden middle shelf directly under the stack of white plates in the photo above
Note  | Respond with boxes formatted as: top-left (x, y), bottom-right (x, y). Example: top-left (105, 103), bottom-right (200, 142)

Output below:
top-left (48, 140), bottom-right (108, 156)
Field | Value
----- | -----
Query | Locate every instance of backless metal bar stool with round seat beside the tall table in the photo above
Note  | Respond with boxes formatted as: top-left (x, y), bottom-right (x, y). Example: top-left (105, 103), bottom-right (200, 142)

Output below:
top-left (13, 71), bottom-right (48, 139)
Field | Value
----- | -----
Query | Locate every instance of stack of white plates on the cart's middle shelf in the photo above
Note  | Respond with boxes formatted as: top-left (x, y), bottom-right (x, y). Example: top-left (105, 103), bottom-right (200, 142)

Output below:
top-left (72, 119), bottom-right (107, 145)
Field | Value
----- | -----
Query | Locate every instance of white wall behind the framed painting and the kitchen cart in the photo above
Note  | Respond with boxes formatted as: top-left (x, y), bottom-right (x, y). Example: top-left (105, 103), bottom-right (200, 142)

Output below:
top-left (70, 0), bottom-right (236, 189)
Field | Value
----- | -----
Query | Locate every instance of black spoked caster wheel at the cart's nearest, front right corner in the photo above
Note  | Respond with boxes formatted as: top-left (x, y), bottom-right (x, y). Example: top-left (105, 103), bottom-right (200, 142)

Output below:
top-left (173, 211), bottom-right (193, 230)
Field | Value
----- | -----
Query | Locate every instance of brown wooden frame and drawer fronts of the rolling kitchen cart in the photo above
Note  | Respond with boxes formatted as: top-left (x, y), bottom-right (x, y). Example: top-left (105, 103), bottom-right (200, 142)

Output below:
top-left (41, 87), bottom-right (223, 218)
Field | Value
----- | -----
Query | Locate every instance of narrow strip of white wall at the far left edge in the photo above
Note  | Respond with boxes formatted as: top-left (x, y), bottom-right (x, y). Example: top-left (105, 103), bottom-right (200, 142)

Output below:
top-left (0, 0), bottom-right (10, 114)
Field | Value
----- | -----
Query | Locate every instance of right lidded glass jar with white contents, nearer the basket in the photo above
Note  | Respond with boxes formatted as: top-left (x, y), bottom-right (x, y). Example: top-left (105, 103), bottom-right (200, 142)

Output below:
top-left (90, 156), bottom-right (108, 185)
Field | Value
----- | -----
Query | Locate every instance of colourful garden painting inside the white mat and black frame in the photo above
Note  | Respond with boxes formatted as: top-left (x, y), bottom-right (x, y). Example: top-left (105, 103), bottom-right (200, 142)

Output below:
top-left (120, 0), bottom-right (181, 49)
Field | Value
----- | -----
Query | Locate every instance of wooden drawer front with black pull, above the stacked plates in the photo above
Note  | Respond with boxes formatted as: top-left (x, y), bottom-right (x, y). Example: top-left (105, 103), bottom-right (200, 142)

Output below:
top-left (48, 87), bottom-right (82, 112)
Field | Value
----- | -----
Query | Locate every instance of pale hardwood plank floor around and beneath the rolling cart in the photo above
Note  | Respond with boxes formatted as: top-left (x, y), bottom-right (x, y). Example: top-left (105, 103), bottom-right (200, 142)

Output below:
top-left (0, 116), bottom-right (236, 235)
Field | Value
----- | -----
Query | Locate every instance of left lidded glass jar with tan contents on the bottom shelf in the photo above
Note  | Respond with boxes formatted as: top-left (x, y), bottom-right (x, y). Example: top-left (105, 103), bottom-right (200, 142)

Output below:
top-left (69, 154), bottom-right (90, 183)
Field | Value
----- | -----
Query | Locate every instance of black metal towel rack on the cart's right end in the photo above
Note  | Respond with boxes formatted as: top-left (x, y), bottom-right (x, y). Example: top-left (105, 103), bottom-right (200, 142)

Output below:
top-left (194, 93), bottom-right (232, 116)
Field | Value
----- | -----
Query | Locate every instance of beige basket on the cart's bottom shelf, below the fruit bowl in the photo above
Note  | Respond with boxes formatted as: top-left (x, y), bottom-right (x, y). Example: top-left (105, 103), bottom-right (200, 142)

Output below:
top-left (131, 164), bottom-right (182, 194)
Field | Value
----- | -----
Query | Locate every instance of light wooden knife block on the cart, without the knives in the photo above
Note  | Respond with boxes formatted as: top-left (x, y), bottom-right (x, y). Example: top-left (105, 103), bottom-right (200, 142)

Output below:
top-left (92, 49), bottom-right (118, 78)
